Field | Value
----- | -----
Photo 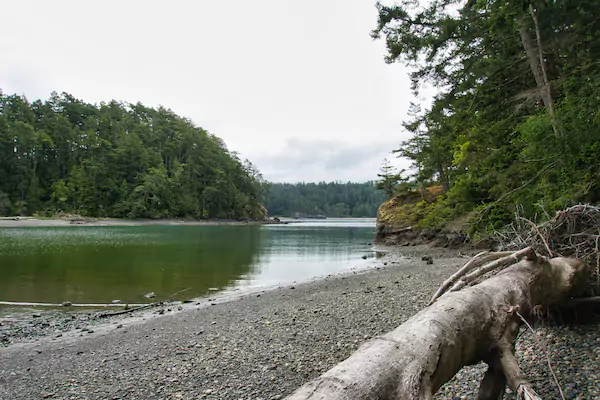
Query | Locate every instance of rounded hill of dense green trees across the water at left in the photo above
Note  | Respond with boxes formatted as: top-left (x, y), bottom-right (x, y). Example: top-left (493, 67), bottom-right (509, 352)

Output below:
top-left (0, 91), bottom-right (264, 219)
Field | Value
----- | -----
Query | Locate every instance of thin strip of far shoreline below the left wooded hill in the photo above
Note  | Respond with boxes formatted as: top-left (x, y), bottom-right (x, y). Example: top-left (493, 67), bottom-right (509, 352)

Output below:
top-left (0, 217), bottom-right (288, 228)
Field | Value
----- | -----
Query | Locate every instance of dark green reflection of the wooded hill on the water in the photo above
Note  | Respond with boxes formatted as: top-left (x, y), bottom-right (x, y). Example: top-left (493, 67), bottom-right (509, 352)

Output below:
top-left (0, 226), bottom-right (262, 303)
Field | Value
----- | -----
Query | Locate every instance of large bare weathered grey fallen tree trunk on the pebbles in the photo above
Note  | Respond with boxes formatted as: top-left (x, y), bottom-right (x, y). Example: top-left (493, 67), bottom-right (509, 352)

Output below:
top-left (288, 251), bottom-right (590, 400)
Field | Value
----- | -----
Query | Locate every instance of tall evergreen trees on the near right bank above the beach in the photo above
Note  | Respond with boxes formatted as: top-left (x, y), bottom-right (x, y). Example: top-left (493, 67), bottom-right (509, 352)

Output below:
top-left (373, 0), bottom-right (600, 231)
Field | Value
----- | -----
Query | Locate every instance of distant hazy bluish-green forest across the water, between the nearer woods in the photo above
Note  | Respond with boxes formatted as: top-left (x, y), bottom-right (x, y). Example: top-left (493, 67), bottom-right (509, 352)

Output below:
top-left (265, 182), bottom-right (385, 217)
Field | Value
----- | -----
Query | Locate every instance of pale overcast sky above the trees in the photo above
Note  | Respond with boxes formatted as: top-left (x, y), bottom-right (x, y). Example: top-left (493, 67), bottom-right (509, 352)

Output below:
top-left (0, 0), bottom-right (426, 182)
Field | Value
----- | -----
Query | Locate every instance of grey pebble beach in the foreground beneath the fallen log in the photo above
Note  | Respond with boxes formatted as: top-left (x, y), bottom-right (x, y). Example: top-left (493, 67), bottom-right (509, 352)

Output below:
top-left (0, 247), bottom-right (600, 400)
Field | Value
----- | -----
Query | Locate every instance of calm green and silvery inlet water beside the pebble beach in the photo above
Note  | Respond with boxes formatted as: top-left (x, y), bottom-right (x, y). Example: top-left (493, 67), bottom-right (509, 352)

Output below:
top-left (0, 220), bottom-right (375, 303)
